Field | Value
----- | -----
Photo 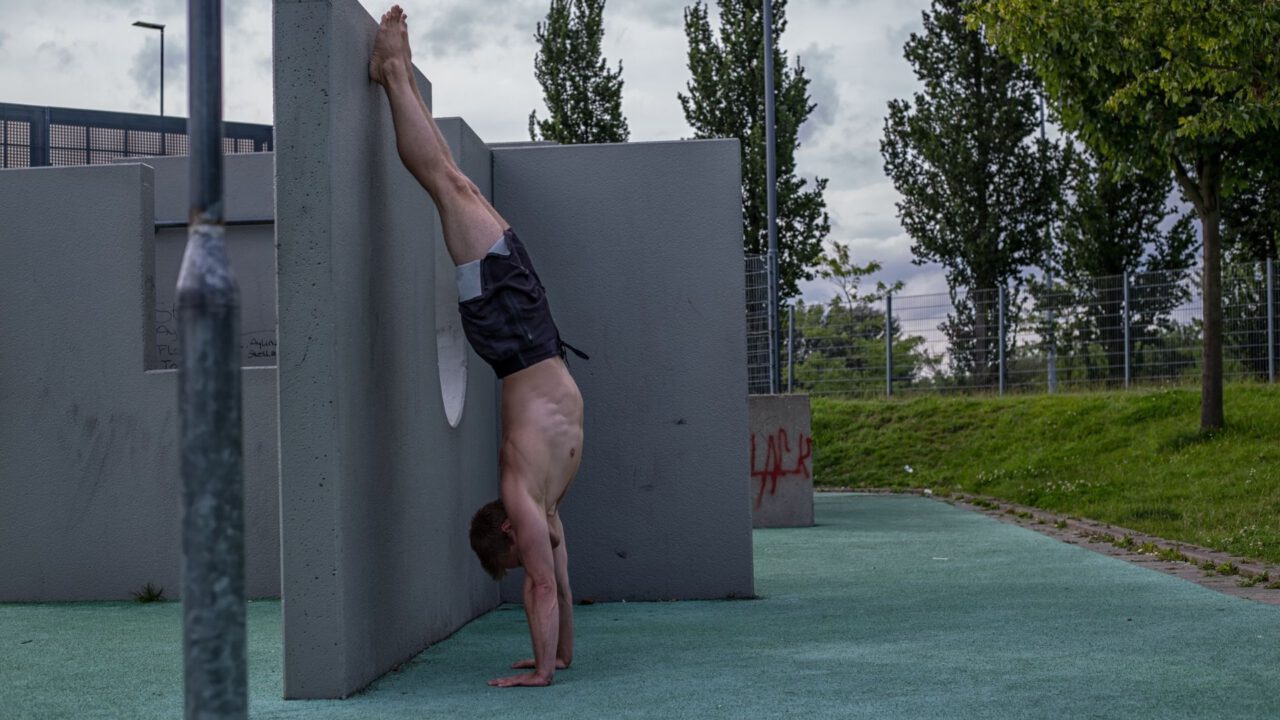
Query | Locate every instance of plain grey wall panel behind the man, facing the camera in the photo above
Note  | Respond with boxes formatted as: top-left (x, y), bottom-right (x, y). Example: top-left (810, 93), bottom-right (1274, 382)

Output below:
top-left (493, 141), bottom-right (753, 601)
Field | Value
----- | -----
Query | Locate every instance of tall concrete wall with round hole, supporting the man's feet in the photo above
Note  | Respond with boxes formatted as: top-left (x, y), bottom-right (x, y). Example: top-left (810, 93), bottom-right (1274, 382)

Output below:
top-left (274, 0), bottom-right (498, 698)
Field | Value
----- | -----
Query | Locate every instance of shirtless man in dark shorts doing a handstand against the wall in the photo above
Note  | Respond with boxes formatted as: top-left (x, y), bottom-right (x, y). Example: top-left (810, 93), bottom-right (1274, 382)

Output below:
top-left (369, 5), bottom-right (585, 688)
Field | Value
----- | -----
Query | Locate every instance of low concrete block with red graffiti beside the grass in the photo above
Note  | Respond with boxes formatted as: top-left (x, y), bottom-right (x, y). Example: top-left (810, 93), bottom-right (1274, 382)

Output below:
top-left (748, 395), bottom-right (813, 528)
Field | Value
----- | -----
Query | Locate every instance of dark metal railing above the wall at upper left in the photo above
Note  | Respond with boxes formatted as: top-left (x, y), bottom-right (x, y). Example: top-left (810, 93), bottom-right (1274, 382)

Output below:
top-left (0, 102), bottom-right (274, 168)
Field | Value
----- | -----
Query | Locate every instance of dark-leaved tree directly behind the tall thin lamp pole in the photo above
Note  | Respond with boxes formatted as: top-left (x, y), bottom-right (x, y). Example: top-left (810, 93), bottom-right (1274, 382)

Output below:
top-left (678, 0), bottom-right (831, 299)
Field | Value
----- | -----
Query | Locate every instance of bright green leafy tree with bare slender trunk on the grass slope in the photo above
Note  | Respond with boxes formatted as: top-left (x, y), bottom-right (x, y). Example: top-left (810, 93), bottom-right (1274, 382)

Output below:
top-left (972, 0), bottom-right (1280, 430)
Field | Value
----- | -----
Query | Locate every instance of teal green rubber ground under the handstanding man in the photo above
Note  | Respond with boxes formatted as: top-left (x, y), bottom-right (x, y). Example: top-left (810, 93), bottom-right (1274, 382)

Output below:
top-left (0, 495), bottom-right (1280, 720)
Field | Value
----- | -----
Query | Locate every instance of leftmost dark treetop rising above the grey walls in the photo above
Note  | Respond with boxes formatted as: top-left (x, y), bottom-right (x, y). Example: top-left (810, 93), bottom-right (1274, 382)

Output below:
top-left (529, 0), bottom-right (631, 145)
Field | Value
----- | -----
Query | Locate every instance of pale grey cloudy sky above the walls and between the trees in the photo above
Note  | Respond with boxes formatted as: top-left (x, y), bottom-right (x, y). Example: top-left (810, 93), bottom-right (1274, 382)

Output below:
top-left (0, 0), bottom-right (946, 300)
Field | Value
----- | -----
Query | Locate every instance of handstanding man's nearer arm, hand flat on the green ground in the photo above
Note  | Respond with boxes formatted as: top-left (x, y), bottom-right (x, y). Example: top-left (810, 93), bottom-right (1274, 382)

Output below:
top-left (489, 479), bottom-right (559, 688)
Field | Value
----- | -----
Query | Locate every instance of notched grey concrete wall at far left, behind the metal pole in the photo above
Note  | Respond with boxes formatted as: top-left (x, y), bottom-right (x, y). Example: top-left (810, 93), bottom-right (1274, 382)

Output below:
top-left (0, 164), bottom-right (279, 601)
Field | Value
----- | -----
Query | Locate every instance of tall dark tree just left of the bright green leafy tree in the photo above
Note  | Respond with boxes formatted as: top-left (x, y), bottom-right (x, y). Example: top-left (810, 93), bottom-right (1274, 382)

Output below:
top-left (881, 0), bottom-right (1061, 383)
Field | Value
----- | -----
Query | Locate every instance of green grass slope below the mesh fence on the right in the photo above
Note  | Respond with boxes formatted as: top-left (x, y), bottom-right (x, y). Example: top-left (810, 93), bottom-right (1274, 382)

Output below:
top-left (813, 384), bottom-right (1280, 562)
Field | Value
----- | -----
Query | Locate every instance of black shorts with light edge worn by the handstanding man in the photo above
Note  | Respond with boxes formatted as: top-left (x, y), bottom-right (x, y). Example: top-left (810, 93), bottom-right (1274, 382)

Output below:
top-left (458, 228), bottom-right (586, 378)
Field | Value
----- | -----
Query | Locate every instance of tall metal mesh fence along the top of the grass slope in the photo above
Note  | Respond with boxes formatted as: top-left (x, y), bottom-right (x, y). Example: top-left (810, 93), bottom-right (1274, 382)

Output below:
top-left (746, 258), bottom-right (1280, 396)
